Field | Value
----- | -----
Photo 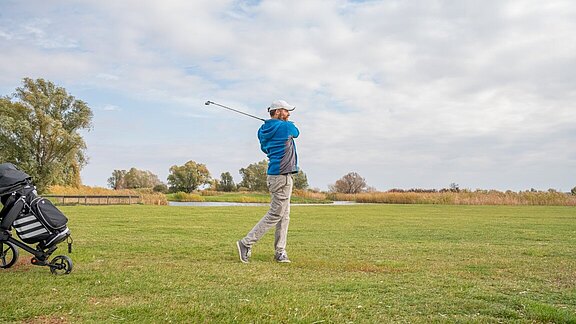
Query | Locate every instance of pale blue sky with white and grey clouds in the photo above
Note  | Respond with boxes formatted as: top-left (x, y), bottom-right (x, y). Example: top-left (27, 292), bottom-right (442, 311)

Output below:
top-left (0, 0), bottom-right (576, 191)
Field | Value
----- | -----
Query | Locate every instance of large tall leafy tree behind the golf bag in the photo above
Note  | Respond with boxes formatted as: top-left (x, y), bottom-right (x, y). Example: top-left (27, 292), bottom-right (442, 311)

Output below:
top-left (0, 78), bottom-right (92, 192)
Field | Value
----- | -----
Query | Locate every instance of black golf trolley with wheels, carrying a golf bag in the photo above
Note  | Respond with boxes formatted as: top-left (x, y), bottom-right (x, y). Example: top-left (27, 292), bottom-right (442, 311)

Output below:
top-left (0, 163), bottom-right (72, 275)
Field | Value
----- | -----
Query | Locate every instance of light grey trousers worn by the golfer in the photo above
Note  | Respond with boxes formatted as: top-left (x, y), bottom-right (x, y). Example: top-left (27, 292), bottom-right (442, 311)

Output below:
top-left (242, 174), bottom-right (293, 254)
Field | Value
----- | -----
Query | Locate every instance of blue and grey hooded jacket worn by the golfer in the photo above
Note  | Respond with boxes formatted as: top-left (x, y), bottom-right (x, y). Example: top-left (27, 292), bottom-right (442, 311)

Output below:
top-left (258, 119), bottom-right (300, 175)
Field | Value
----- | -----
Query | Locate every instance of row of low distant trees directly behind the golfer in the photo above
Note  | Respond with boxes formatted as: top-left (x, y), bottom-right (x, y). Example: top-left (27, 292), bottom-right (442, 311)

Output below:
top-left (108, 160), bottom-right (308, 193)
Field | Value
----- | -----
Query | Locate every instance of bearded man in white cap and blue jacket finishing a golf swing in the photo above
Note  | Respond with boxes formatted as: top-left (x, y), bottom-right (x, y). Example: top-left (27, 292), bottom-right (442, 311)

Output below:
top-left (236, 100), bottom-right (300, 263)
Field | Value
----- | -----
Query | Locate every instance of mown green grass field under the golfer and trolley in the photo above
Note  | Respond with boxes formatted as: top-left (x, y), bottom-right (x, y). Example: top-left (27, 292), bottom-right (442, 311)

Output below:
top-left (0, 205), bottom-right (576, 323)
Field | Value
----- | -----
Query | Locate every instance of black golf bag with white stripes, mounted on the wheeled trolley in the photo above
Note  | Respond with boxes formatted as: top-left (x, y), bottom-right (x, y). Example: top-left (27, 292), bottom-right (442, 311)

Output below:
top-left (0, 163), bottom-right (70, 249)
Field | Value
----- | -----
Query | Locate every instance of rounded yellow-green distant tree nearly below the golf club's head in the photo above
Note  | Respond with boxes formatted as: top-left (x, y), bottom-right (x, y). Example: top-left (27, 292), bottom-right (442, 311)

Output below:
top-left (168, 161), bottom-right (211, 193)
